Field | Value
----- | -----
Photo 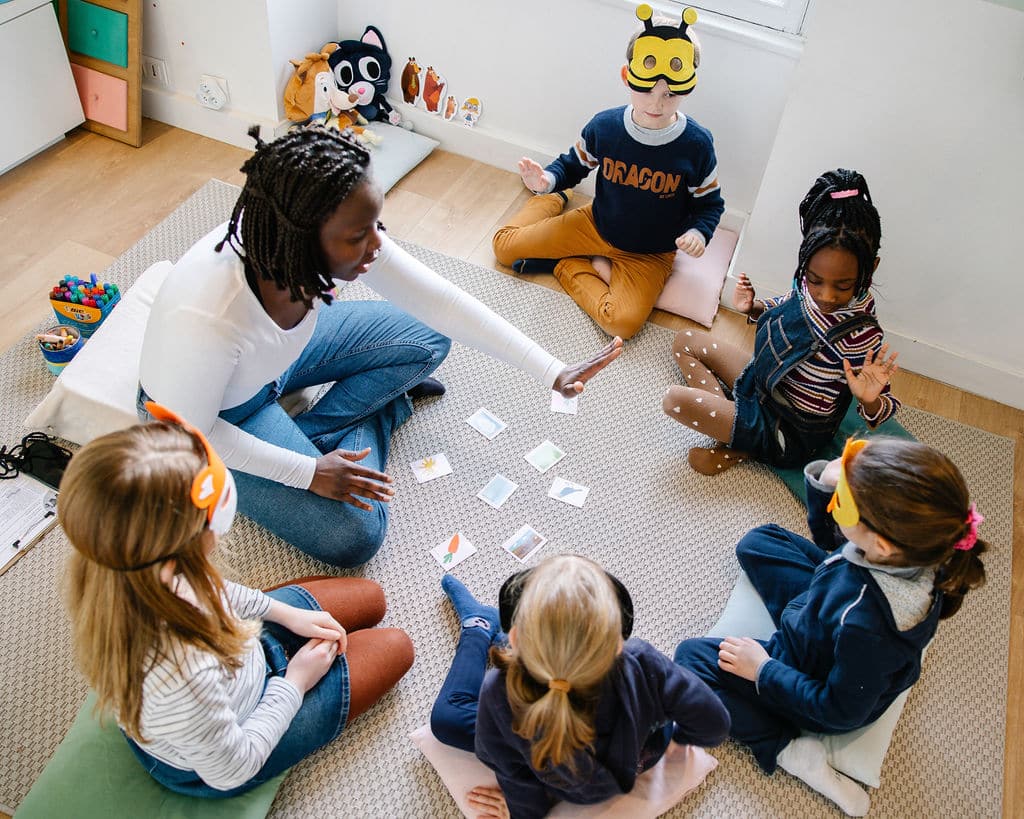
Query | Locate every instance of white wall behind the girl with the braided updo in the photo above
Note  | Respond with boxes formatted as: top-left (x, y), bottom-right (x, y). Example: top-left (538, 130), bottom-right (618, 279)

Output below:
top-left (737, 0), bottom-right (1024, 407)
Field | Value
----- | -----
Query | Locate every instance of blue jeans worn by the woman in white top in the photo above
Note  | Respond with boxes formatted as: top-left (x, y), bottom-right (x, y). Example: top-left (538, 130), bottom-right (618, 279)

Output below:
top-left (139, 301), bottom-right (452, 568)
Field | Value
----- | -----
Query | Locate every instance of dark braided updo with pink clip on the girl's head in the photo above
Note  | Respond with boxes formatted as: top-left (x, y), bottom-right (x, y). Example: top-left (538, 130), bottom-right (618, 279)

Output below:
top-left (793, 168), bottom-right (882, 297)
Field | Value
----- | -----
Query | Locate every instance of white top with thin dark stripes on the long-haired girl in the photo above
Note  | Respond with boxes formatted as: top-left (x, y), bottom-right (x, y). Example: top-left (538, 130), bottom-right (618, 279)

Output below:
top-left (130, 583), bottom-right (302, 790)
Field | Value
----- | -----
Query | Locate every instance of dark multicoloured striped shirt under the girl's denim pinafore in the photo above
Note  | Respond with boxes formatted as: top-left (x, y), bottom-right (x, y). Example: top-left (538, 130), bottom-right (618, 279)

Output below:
top-left (762, 284), bottom-right (901, 427)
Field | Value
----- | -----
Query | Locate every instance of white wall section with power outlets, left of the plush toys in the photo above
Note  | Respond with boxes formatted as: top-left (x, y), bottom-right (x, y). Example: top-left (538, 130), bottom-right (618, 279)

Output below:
top-left (142, 0), bottom-right (337, 148)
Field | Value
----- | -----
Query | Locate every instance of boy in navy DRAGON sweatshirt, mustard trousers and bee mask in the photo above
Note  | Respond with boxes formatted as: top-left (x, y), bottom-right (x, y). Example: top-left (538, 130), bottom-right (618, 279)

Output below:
top-left (494, 4), bottom-right (725, 339)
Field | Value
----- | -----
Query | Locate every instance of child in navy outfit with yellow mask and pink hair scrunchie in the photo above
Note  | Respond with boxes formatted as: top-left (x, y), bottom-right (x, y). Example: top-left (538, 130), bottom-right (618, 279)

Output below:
top-left (676, 437), bottom-right (986, 816)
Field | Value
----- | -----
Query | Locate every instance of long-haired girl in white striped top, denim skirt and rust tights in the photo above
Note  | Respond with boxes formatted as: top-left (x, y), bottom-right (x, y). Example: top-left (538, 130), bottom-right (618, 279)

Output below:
top-left (57, 402), bottom-right (413, 799)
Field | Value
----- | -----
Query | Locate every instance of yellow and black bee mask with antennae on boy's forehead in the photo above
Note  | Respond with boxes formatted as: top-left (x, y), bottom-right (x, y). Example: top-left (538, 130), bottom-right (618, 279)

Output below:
top-left (626, 3), bottom-right (697, 94)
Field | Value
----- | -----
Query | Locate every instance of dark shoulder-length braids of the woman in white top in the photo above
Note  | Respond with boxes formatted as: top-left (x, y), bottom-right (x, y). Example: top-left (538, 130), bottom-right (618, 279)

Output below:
top-left (215, 125), bottom-right (370, 307)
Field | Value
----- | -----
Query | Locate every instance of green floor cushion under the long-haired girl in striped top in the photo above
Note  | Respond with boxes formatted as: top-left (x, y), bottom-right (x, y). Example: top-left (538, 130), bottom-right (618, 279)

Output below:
top-left (14, 691), bottom-right (287, 819)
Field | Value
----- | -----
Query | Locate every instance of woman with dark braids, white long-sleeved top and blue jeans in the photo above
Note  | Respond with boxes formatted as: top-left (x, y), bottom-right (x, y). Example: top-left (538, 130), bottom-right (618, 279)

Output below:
top-left (138, 127), bottom-right (622, 566)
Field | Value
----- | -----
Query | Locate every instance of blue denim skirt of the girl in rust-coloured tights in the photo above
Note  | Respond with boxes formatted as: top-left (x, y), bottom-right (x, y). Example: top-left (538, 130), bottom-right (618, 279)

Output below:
top-left (128, 586), bottom-right (349, 799)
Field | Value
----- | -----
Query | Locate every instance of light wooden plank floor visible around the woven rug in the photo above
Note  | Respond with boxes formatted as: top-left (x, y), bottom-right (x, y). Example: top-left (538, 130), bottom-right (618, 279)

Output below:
top-left (0, 120), bottom-right (1024, 817)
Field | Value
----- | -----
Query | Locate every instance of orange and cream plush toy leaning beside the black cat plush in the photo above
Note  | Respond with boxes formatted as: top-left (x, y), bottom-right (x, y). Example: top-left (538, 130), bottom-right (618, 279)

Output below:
top-left (285, 43), bottom-right (380, 146)
